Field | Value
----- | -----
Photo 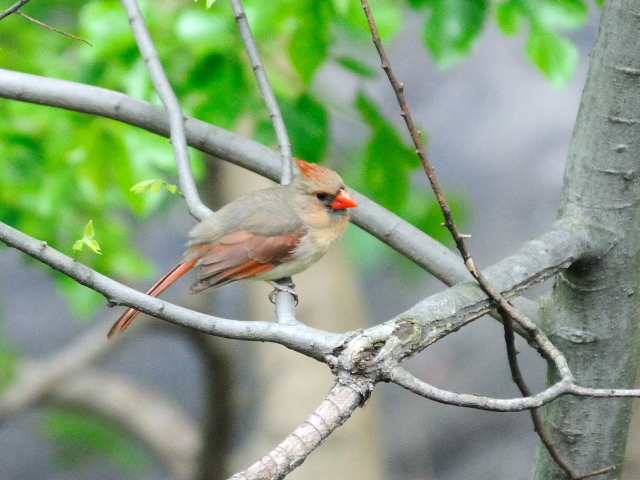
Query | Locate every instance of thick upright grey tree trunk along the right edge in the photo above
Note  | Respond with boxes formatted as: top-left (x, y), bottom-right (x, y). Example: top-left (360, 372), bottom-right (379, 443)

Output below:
top-left (533, 0), bottom-right (640, 480)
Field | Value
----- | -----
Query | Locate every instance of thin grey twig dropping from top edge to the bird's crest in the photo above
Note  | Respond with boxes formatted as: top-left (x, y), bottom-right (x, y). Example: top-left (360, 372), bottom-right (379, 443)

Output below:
top-left (231, 0), bottom-right (293, 185)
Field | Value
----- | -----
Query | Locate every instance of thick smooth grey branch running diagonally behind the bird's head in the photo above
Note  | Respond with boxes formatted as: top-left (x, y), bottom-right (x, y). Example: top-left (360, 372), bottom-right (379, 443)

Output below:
top-left (0, 69), bottom-right (476, 288)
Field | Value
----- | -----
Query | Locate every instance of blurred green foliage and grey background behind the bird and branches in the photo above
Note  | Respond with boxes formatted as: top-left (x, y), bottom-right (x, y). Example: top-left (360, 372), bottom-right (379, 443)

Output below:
top-left (0, 0), bottom-right (640, 480)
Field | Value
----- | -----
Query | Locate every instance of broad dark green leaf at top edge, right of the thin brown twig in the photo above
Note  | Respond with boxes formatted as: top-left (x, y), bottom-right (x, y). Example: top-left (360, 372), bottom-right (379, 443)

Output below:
top-left (424, 0), bottom-right (489, 68)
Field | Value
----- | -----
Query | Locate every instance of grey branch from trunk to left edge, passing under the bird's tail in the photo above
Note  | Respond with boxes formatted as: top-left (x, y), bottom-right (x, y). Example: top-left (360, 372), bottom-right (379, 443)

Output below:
top-left (0, 214), bottom-right (576, 368)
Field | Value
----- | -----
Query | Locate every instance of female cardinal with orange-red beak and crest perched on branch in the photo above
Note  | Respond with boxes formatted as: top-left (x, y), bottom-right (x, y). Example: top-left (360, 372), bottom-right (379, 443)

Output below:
top-left (108, 159), bottom-right (358, 338)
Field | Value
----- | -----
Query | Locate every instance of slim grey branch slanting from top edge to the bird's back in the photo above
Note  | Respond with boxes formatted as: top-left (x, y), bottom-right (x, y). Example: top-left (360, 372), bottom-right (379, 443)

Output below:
top-left (122, 0), bottom-right (212, 220)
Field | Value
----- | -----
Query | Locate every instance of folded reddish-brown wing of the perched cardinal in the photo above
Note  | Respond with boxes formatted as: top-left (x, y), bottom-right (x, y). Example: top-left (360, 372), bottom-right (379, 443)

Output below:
top-left (185, 228), bottom-right (305, 293)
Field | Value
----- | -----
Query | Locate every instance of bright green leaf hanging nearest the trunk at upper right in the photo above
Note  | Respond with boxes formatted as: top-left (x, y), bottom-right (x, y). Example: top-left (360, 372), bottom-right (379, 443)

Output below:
top-left (527, 26), bottom-right (578, 88)
